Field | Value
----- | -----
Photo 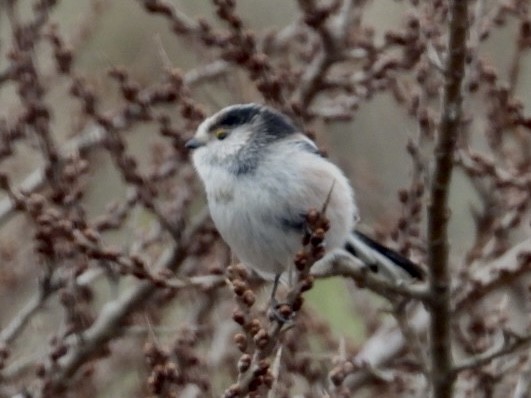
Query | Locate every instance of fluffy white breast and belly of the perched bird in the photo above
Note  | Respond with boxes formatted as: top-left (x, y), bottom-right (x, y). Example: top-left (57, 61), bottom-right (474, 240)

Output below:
top-left (194, 143), bottom-right (357, 278)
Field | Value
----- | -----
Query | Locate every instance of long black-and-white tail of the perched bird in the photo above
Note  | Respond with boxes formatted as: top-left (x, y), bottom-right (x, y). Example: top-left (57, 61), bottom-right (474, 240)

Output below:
top-left (345, 231), bottom-right (425, 280)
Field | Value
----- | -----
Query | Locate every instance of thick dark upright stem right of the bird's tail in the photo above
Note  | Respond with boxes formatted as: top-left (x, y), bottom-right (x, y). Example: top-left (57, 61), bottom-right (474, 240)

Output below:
top-left (428, 0), bottom-right (468, 398)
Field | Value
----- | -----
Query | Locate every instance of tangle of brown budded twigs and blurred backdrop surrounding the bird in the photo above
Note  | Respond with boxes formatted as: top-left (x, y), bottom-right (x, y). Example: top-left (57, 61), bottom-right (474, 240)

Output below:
top-left (0, 0), bottom-right (531, 398)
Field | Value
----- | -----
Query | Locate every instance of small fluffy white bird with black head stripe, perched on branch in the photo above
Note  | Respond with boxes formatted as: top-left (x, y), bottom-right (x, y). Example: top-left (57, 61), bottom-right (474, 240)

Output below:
top-left (186, 103), bottom-right (423, 281)
